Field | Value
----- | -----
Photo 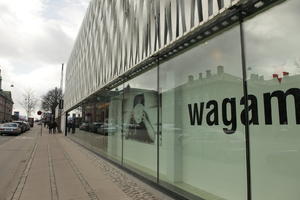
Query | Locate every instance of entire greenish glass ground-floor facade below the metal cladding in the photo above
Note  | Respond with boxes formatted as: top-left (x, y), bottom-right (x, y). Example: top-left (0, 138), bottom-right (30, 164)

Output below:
top-left (67, 0), bottom-right (300, 200)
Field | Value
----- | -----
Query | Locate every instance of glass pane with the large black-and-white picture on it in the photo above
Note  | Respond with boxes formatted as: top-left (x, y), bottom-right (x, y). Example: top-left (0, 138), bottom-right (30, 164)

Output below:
top-left (123, 68), bottom-right (158, 177)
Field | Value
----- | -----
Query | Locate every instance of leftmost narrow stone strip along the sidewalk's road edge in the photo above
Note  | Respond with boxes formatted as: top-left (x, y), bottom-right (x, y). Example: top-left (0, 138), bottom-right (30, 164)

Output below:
top-left (10, 142), bottom-right (38, 200)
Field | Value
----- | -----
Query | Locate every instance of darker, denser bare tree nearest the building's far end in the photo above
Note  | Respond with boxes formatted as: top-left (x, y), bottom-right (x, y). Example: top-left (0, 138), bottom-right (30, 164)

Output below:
top-left (42, 87), bottom-right (62, 118)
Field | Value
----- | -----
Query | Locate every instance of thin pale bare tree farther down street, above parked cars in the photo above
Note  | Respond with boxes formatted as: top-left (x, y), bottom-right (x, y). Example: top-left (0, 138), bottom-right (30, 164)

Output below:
top-left (19, 89), bottom-right (38, 118)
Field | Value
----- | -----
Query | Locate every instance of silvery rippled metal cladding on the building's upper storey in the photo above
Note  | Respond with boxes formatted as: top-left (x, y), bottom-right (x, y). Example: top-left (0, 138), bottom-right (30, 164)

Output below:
top-left (64, 0), bottom-right (242, 110)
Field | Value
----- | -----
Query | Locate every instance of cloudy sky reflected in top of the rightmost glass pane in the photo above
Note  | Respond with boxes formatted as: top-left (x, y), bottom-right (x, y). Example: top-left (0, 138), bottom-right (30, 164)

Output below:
top-left (244, 1), bottom-right (300, 79)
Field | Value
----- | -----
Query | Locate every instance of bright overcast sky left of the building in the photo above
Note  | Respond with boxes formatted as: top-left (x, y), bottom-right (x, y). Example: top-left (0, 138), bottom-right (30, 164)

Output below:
top-left (0, 0), bottom-right (90, 115)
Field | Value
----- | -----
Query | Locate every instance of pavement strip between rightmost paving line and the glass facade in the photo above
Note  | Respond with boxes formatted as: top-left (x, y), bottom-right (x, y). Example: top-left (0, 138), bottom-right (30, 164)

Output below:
top-left (59, 137), bottom-right (172, 200)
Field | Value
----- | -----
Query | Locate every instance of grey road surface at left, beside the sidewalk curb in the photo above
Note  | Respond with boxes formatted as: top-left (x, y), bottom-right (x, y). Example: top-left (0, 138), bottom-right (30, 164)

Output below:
top-left (0, 127), bottom-right (39, 200)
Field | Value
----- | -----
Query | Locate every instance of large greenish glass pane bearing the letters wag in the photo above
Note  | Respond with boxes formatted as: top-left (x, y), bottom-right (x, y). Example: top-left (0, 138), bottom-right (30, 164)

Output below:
top-left (159, 27), bottom-right (246, 200)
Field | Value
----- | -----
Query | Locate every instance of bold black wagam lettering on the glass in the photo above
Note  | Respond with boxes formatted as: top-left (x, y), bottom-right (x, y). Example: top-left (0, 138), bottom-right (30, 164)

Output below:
top-left (188, 88), bottom-right (300, 134)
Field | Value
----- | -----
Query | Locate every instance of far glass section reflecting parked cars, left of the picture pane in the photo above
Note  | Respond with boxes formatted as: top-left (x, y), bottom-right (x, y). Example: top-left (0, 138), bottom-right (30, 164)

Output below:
top-left (68, 86), bottom-right (123, 161)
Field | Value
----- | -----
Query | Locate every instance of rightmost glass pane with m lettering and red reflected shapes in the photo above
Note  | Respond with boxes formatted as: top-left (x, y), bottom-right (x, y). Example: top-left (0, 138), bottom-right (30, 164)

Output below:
top-left (245, 0), bottom-right (300, 200)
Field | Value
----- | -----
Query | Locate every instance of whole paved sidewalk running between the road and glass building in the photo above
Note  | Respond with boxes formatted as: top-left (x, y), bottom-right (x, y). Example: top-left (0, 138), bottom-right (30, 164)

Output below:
top-left (12, 129), bottom-right (171, 200)
